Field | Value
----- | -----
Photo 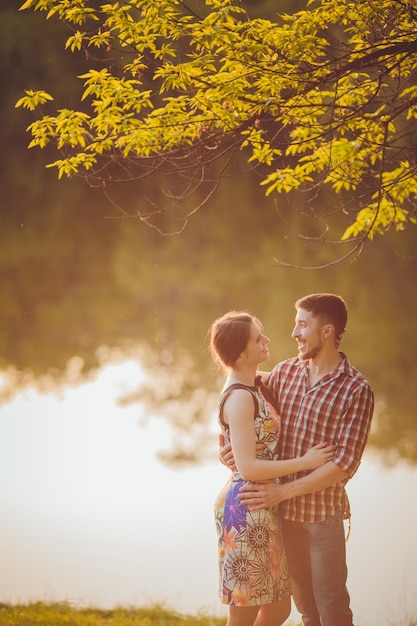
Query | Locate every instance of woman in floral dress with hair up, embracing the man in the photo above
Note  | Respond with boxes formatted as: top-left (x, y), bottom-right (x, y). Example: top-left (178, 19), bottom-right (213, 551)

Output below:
top-left (210, 311), bottom-right (334, 626)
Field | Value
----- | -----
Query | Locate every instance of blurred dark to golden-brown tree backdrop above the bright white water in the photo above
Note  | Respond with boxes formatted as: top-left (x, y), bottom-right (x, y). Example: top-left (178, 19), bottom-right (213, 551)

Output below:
top-left (0, 0), bottom-right (417, 461)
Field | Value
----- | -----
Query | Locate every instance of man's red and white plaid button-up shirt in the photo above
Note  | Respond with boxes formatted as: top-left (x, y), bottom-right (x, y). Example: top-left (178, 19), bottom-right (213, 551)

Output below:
top-left (268, 353), bottom-right (374, 522)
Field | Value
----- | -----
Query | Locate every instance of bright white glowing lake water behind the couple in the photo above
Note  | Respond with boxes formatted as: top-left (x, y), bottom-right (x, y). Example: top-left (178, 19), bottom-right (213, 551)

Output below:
top-left (0, 361), bottom-right (417, 626)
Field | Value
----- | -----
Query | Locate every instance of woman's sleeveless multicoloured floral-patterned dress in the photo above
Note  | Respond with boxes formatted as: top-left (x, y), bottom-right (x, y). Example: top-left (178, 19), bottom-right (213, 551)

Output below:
top-left (214, 385), bottom-right (291, 607)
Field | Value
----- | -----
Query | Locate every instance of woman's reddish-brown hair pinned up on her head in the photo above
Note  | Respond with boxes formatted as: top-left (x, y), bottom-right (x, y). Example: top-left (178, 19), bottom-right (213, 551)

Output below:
top-left (209, 311), bottom-right (262, 368)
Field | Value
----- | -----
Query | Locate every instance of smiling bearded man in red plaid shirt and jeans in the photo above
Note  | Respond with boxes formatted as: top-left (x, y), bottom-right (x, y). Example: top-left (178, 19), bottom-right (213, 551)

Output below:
top-left (221, 293), bottom-right (374, 626)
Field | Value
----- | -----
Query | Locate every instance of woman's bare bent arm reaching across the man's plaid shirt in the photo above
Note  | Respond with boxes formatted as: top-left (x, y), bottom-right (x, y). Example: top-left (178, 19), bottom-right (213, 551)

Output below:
top-left (223, 389), bottom-right (335, 481)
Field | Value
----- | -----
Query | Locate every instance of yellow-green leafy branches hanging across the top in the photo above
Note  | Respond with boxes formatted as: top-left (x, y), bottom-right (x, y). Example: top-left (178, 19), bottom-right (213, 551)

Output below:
top-left (16, 0), bottom-right (417, 256)
